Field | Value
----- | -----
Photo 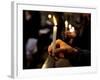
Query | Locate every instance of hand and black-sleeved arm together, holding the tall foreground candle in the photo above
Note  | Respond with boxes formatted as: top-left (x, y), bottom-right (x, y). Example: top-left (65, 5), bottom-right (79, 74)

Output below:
top-left (48, 39), bottom-right (91, 66)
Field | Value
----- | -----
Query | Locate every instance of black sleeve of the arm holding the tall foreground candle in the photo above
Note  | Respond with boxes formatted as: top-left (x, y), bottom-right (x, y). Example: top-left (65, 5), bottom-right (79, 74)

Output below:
top-left (65, 49), bottom-right (91, 66)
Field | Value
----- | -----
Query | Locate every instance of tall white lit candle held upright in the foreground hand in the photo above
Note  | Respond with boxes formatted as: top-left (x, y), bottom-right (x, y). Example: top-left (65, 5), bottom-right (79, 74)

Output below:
top-left (52, 16), bottom-right (57, 56)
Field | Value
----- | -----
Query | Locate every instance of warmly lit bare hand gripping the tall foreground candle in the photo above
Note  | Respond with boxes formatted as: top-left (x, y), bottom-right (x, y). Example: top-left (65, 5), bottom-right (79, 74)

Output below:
top-left (48, 39), bottom-right (77, 57)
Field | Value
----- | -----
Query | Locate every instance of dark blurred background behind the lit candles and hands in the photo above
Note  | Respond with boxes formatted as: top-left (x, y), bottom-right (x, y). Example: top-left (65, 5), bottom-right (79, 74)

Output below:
top-left (23, 10), bottom-right (91, 69)
